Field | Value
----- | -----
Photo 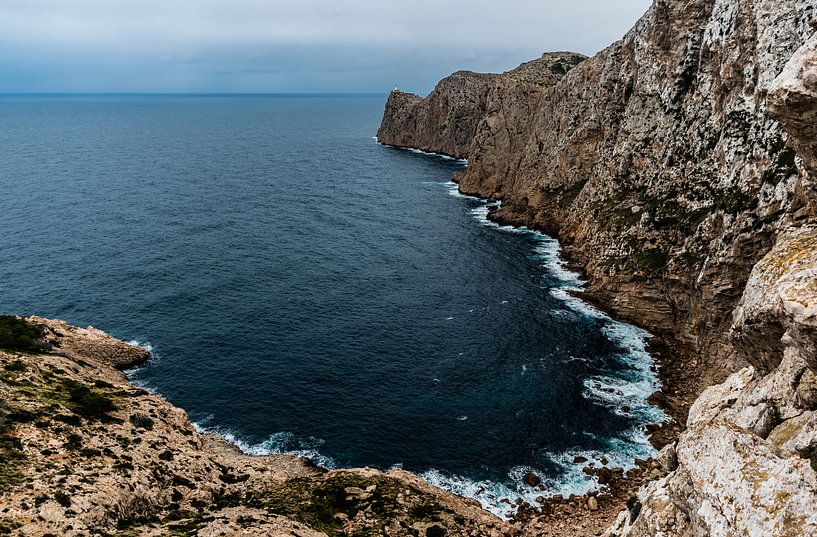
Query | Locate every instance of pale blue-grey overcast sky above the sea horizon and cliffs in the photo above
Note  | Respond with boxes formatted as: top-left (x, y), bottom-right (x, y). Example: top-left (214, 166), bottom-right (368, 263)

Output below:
top-left (0, 0), bottom-right (650, 93)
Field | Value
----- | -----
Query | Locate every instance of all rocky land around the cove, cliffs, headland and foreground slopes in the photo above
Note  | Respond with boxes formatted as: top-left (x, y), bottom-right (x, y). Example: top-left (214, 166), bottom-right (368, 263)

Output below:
top-left (0, 0), bottom-right (817, 537)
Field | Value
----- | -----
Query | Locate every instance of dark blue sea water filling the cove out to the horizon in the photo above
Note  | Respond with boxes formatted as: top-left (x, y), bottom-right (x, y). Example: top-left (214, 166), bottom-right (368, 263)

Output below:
top-left (0, 96), bottom-right (662, 513)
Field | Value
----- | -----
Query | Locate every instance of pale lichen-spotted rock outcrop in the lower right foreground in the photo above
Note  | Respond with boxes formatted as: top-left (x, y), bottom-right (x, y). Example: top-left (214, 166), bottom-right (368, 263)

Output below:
top-left (607, 224), bottom-right (817, 537)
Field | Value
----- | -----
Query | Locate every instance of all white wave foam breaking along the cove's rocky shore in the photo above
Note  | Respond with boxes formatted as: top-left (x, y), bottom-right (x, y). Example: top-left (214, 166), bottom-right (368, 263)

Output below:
top-left (121, 142), bottom-right (667, 517)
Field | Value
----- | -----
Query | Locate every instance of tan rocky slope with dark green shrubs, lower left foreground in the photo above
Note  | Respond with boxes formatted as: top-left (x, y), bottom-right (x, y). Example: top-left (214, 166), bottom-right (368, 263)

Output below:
top-left (0, 318), bottom-right (510, 537)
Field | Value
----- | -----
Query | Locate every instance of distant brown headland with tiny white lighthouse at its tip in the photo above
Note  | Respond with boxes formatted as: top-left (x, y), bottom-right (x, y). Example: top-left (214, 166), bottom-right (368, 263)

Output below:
top-left (377, 53), bottom-right (584, 158)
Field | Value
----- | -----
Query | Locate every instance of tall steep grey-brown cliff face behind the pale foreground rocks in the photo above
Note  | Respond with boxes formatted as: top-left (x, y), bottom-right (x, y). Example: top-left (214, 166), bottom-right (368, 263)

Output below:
top-left (380, 0), bottom-right (815, 385)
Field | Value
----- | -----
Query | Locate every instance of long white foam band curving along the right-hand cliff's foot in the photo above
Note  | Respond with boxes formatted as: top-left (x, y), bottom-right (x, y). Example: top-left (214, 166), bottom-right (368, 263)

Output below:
top-left (404, 155), bottom-right (667, 516)
